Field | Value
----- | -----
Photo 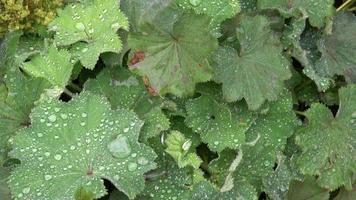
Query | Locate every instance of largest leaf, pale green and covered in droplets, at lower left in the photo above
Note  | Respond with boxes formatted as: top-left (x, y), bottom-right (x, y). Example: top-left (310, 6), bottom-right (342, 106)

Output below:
top-left (9, 92), bottom-right (156, 200)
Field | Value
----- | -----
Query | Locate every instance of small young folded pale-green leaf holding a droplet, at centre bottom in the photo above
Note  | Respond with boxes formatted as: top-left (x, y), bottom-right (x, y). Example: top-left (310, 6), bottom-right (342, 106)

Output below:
top-left (165, 131), bottom-right (202, 169)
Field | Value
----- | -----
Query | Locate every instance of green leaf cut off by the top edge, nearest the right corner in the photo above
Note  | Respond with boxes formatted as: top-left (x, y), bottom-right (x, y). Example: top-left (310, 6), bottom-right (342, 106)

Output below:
top-left (258, 0), bottom-right (334, 28)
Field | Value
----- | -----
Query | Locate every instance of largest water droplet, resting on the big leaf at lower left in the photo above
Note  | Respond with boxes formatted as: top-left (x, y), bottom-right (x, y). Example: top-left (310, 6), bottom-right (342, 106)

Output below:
top-left (108, 135), bottom-right (131, 158)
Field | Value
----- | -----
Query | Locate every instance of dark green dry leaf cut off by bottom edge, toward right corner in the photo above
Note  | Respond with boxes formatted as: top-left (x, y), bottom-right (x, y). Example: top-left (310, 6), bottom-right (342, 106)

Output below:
top-left (287, 177), bottom-right (329, 200)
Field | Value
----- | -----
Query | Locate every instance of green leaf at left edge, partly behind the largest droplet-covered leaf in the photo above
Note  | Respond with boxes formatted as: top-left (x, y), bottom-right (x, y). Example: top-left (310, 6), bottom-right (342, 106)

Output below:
top-left (0, 66), bottom-right (49, 161)
